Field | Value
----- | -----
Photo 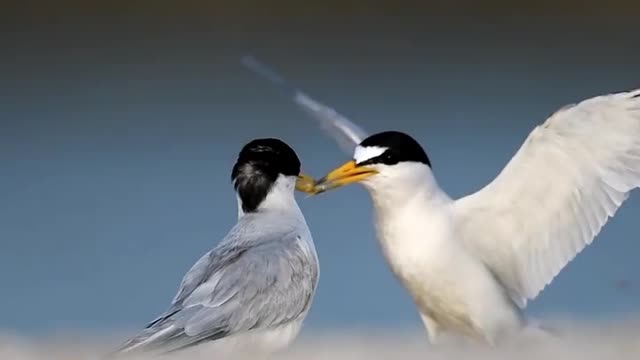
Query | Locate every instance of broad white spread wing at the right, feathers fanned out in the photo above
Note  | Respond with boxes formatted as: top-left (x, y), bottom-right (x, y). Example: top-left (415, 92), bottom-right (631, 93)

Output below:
top-left (456, 90), bottom-right (640, 306)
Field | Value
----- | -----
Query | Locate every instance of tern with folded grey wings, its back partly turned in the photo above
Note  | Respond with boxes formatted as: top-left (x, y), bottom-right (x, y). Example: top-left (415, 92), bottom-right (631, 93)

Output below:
top-left (116, 139), bottom-right (319, 357)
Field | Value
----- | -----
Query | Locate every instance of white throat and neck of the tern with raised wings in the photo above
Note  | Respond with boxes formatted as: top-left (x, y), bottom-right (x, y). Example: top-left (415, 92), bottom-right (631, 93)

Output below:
top-left (367, 164), bottom-right (451, 215)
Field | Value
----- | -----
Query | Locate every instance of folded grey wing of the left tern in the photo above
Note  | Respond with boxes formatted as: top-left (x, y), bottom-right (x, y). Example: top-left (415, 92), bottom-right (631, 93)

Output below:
top-left (119, 233), bottom-right (318, 352)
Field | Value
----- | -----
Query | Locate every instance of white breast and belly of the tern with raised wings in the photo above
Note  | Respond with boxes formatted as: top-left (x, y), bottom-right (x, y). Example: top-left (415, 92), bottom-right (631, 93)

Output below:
top-left (368, 166), bottom-right (519, 341)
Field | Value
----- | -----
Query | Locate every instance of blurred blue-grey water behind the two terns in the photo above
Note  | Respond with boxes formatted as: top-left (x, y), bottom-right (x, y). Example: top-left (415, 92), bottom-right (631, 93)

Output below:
top-left (0, 7), bottom-right (640, 333)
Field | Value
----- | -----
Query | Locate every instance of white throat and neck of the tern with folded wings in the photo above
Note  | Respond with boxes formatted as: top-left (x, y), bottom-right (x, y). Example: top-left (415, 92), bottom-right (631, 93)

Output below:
top-left (237, 176), bottom-right (302, 218)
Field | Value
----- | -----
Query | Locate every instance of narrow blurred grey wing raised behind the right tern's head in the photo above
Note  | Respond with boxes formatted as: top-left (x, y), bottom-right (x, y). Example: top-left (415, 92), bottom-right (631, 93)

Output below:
top-left (242, 57), bottom-right (367, 155)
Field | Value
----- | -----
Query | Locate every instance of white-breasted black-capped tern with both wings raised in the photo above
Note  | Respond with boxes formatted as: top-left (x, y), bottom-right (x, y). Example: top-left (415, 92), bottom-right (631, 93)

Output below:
top-left (245, 60), bottom-right (640, 344)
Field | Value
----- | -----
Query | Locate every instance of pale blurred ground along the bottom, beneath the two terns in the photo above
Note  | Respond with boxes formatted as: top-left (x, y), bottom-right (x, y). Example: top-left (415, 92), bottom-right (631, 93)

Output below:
top-left (0, 320), bottom-right (640, 360)
